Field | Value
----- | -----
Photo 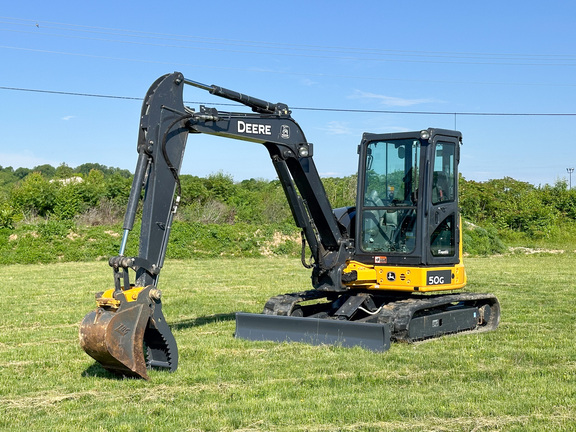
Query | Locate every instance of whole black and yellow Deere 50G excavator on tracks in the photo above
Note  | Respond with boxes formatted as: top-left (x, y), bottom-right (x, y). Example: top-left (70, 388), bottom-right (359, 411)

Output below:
top-left (79, 72), bottom-right (500, 379)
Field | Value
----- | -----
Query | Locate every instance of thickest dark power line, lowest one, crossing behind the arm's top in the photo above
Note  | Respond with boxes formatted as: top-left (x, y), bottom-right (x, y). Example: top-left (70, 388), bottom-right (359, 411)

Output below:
top-left (0, 86), bottom-right (576, 117)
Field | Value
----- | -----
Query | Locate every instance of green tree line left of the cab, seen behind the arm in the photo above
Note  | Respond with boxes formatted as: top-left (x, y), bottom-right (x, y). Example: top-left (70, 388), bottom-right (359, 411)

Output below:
top-left (0, 164), bottom-right (356, 227)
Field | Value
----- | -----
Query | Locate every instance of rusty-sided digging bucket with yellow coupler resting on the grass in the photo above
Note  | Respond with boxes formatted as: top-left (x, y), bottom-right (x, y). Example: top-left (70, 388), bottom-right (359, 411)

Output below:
top-left (79, 287), bottom-right (178, 379)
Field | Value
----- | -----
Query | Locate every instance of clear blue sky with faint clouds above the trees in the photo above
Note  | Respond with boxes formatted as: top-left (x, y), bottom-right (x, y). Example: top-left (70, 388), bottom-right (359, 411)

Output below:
top-left (0, 0), bottom-right (576, 185)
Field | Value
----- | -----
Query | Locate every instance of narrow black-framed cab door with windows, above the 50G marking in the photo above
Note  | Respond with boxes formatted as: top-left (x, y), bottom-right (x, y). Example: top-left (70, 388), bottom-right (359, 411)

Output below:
top-left (425, 135), bottom-right (460, 265)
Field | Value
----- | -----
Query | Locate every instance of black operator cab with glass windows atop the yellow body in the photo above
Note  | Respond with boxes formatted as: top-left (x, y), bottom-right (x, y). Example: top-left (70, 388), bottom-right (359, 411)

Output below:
top-left (355, 129), bottom-right (461, 265)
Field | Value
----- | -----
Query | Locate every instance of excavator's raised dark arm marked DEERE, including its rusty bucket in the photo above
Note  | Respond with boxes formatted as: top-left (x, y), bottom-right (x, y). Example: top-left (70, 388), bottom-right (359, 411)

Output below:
top-left (80, 72), bottom-right (353, 379)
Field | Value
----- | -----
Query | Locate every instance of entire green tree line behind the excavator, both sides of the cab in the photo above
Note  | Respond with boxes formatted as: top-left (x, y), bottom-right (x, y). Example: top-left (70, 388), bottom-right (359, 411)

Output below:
top-left (0, 164), bottom-right (576, 250)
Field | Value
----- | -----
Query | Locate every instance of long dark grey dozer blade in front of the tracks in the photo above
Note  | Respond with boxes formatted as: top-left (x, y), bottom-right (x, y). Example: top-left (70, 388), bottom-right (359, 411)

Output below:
top-left (235, 313), bottom-right (390, 351)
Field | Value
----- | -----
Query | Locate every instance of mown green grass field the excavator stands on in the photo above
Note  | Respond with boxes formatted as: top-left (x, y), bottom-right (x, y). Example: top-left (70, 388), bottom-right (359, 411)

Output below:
top-left (0, 254), bottom-right (576, 431)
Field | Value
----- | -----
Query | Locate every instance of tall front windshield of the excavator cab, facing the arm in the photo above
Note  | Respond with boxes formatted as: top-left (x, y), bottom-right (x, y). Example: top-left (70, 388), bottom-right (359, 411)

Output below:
top-left (361, 139), bottom-right (420, 253)
